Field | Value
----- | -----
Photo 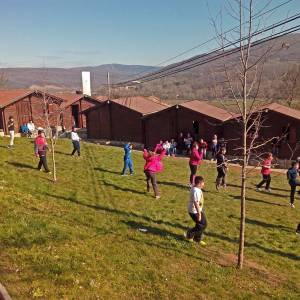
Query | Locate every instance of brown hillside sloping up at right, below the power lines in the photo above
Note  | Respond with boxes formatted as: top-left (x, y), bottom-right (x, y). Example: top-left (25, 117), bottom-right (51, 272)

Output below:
top-left (136, 33), bottom-right (300, 100)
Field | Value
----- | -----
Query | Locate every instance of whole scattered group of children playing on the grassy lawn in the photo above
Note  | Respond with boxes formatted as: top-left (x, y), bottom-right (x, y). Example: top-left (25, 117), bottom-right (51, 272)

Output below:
top-left (8, 122), bottom-right (300, 245)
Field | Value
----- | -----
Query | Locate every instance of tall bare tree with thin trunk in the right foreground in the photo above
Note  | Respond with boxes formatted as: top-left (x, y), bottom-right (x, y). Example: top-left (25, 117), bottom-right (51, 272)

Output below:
top-left (212, 0), bottom-right (292, 269)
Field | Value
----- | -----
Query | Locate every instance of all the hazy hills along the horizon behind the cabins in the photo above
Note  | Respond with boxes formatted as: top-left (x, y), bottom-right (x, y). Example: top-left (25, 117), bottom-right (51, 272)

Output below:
top-left (0, 33), bottom-right (300, 101)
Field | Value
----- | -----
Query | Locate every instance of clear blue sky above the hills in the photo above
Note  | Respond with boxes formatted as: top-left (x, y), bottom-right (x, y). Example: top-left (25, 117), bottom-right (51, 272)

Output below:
top-left (0, 0), bottom-right (300, 67)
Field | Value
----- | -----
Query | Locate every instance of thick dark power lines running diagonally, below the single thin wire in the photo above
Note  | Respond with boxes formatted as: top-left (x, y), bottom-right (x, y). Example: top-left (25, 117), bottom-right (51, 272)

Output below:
top-left (115, 13), bottom-right (300, 86)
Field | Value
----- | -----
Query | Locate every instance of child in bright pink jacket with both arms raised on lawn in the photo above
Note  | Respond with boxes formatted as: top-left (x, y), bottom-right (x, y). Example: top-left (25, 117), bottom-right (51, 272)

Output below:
top-left (143, 149), bottom-right (166, 199)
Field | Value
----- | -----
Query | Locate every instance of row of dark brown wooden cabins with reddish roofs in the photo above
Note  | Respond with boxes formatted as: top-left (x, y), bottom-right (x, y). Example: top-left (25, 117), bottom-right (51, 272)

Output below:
top-left (0, 89), bottom-right (300, 159)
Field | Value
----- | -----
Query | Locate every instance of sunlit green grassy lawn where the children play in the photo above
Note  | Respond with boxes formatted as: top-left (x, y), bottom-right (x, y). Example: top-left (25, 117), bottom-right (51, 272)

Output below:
top-left (0, 139), bottom-right (300, 299)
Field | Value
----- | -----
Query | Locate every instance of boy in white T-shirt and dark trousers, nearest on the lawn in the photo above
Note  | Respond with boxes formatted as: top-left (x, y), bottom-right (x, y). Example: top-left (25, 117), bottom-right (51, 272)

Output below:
top-left (186, 176), bottom-right (207, 246)
